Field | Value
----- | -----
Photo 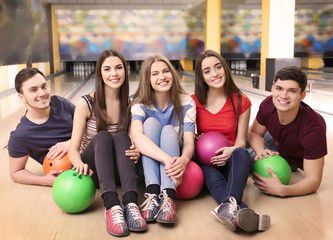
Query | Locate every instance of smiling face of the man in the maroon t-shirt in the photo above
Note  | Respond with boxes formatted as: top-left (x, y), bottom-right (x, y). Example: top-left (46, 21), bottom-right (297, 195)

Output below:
top-left (271, 79), bottom-right (306, 114)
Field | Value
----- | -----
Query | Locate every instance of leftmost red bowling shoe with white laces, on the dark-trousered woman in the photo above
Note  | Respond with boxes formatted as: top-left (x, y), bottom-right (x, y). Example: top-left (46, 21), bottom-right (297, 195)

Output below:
top-left (105, 205), bottom-right (129, 237)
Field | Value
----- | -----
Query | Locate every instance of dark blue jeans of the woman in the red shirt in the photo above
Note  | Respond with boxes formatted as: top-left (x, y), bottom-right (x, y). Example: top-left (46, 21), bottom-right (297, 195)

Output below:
top-left (200, 148), bottom-right (254, 208)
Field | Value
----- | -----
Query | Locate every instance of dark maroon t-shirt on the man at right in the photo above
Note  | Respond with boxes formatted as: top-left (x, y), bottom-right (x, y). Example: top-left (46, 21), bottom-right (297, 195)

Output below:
top-left (256, 96), bottom-right (327, 169)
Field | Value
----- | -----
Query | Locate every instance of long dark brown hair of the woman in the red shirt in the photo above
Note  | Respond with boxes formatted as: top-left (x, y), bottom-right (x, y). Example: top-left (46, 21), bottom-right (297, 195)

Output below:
top-left (194, 50), bottom-right (242, 119)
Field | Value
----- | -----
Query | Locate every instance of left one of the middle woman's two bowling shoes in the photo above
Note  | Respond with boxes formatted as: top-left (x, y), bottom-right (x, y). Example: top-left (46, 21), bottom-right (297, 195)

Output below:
top-left (140, 193), bottom-right (160, 222)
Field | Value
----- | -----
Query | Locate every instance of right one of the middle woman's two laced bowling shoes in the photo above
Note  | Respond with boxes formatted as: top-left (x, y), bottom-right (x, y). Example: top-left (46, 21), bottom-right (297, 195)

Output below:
top-left (156, 190), bottom-right (177, 223)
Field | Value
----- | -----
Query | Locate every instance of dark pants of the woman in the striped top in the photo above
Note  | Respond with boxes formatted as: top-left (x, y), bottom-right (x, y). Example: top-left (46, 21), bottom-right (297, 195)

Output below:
top-left (81, 131), bottom-right (137, 195)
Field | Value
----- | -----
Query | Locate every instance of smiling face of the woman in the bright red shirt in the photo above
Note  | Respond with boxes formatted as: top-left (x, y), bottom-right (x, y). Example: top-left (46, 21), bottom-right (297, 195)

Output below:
top-left (201, 56), bottom-right (226, 88)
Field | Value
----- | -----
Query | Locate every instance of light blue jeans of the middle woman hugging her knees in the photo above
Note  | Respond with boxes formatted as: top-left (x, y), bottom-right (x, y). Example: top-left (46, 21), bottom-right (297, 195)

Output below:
top-left (142, 118), bottom-right (181, 191)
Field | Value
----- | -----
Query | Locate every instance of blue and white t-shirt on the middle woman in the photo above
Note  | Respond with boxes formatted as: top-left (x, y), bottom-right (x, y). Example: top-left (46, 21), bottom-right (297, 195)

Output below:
top-left (131, 94), bottom-right (196, 133)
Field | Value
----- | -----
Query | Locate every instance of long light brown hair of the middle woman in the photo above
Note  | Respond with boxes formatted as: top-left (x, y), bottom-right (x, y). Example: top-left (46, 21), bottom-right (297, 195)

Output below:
top-left (131, 54), bottom-right (187, 133)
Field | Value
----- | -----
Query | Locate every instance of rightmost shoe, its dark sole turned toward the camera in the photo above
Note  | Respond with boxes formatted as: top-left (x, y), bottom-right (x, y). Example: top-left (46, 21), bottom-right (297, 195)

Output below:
top-left (237, 208), bottom-right (271, 232)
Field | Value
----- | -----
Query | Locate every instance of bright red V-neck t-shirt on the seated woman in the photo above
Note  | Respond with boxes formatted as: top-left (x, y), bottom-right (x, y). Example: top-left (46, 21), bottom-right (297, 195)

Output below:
top-left (192, 93), bottom-right (251, 146)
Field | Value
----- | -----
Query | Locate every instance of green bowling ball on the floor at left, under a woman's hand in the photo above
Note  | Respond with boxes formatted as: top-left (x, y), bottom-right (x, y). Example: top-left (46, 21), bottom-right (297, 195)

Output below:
top-left (52, 170), bottom-right (96, 213)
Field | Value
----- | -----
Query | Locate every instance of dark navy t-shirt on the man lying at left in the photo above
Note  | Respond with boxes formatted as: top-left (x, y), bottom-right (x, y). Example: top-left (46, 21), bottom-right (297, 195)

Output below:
top-left (8, 96), bottom-right (75, 164)
